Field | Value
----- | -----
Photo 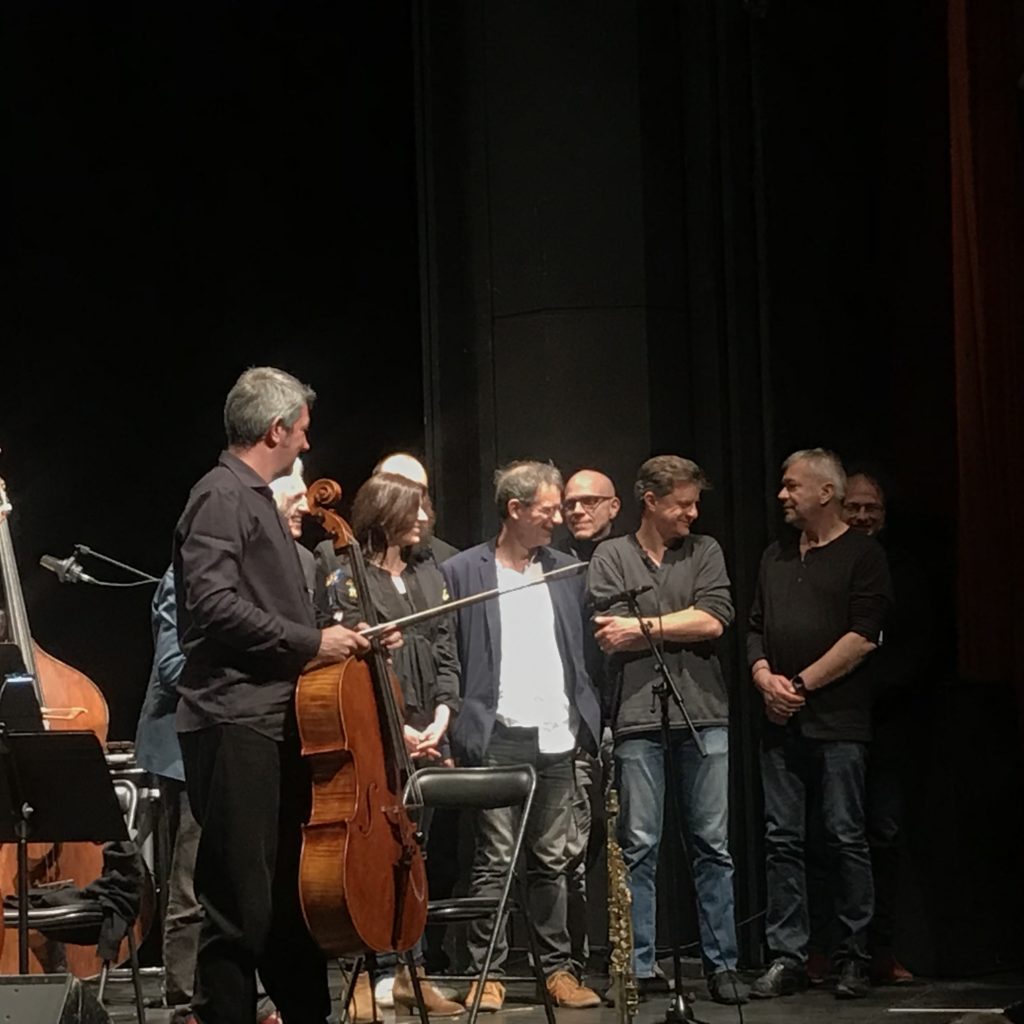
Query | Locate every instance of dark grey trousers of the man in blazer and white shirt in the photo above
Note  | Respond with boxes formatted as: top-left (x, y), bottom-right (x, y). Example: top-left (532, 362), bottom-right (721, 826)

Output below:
top-left (466, 724), bottom-right (575, 975)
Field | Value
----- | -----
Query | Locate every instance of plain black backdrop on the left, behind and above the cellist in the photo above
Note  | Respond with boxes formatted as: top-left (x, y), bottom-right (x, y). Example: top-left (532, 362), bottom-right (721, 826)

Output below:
top-left (0, 0), bottom-right (423, 739)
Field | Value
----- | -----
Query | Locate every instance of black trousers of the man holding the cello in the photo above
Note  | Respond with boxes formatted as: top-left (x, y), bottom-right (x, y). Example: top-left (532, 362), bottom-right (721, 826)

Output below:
top-left (180, 725), bottom-right (331, 1024)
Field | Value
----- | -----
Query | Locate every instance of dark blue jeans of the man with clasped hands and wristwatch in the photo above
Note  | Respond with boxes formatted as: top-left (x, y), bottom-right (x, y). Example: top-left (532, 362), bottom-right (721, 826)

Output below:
top-left (761, 729), bottom-right (874, 965)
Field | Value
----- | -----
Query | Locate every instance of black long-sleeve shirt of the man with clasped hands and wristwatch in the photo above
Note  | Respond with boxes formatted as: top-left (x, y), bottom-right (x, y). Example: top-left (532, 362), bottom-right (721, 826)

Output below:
top-left (746, 529), bottom-right (892, 742)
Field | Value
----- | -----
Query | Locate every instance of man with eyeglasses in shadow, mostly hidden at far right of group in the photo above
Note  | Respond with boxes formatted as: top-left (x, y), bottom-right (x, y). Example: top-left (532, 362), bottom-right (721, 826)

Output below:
top-left (843, 465), bottom-right (933, 985)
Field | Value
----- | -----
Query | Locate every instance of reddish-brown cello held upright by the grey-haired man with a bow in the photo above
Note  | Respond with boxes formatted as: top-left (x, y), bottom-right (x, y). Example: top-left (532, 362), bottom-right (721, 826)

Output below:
top-left (295, 480), bottom-right (427, 956)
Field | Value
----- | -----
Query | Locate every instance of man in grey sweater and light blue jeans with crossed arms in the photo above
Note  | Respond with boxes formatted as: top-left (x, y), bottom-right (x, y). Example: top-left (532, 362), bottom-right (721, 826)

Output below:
top-left (588, 456), bottom-right (748, 1005)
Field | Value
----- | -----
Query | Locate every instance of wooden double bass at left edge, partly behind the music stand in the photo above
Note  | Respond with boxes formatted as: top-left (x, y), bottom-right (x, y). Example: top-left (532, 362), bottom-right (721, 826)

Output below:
top-left (0, 471), bottom-right (144, 979)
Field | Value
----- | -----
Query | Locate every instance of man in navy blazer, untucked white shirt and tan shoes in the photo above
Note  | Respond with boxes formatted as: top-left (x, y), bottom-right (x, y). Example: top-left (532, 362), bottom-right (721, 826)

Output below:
top-left (441, 462), bottom-right (600, 1011)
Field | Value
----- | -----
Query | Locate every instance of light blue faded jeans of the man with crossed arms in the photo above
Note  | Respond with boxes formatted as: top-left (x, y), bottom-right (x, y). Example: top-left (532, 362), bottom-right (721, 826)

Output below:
top-left (615, 726), bottom-right (737, 978)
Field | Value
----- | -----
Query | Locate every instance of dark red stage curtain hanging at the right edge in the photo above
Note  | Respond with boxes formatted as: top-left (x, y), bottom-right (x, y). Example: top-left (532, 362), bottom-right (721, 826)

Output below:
top-left (946, 0), bottom-right (1024, 708)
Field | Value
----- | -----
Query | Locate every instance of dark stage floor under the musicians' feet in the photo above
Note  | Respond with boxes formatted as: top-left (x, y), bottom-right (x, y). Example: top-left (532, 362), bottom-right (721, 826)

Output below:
top-left (114, 972), bottom-right (1024, 1024)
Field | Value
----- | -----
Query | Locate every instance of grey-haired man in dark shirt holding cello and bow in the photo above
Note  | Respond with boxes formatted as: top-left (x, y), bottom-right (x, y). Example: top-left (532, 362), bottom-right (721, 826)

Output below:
top-left (173, 367), bottom-right (369, 1024)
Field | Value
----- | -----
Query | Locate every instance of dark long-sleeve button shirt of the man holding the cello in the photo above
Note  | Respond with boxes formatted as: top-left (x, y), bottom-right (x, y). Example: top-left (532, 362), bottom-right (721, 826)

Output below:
top-left (174, 452), bottom-right (321, 739)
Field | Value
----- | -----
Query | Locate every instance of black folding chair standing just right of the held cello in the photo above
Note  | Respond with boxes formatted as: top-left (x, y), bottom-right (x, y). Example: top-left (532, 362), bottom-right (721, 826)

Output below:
top-left (404, 764), bottom-right (555, 1024)
